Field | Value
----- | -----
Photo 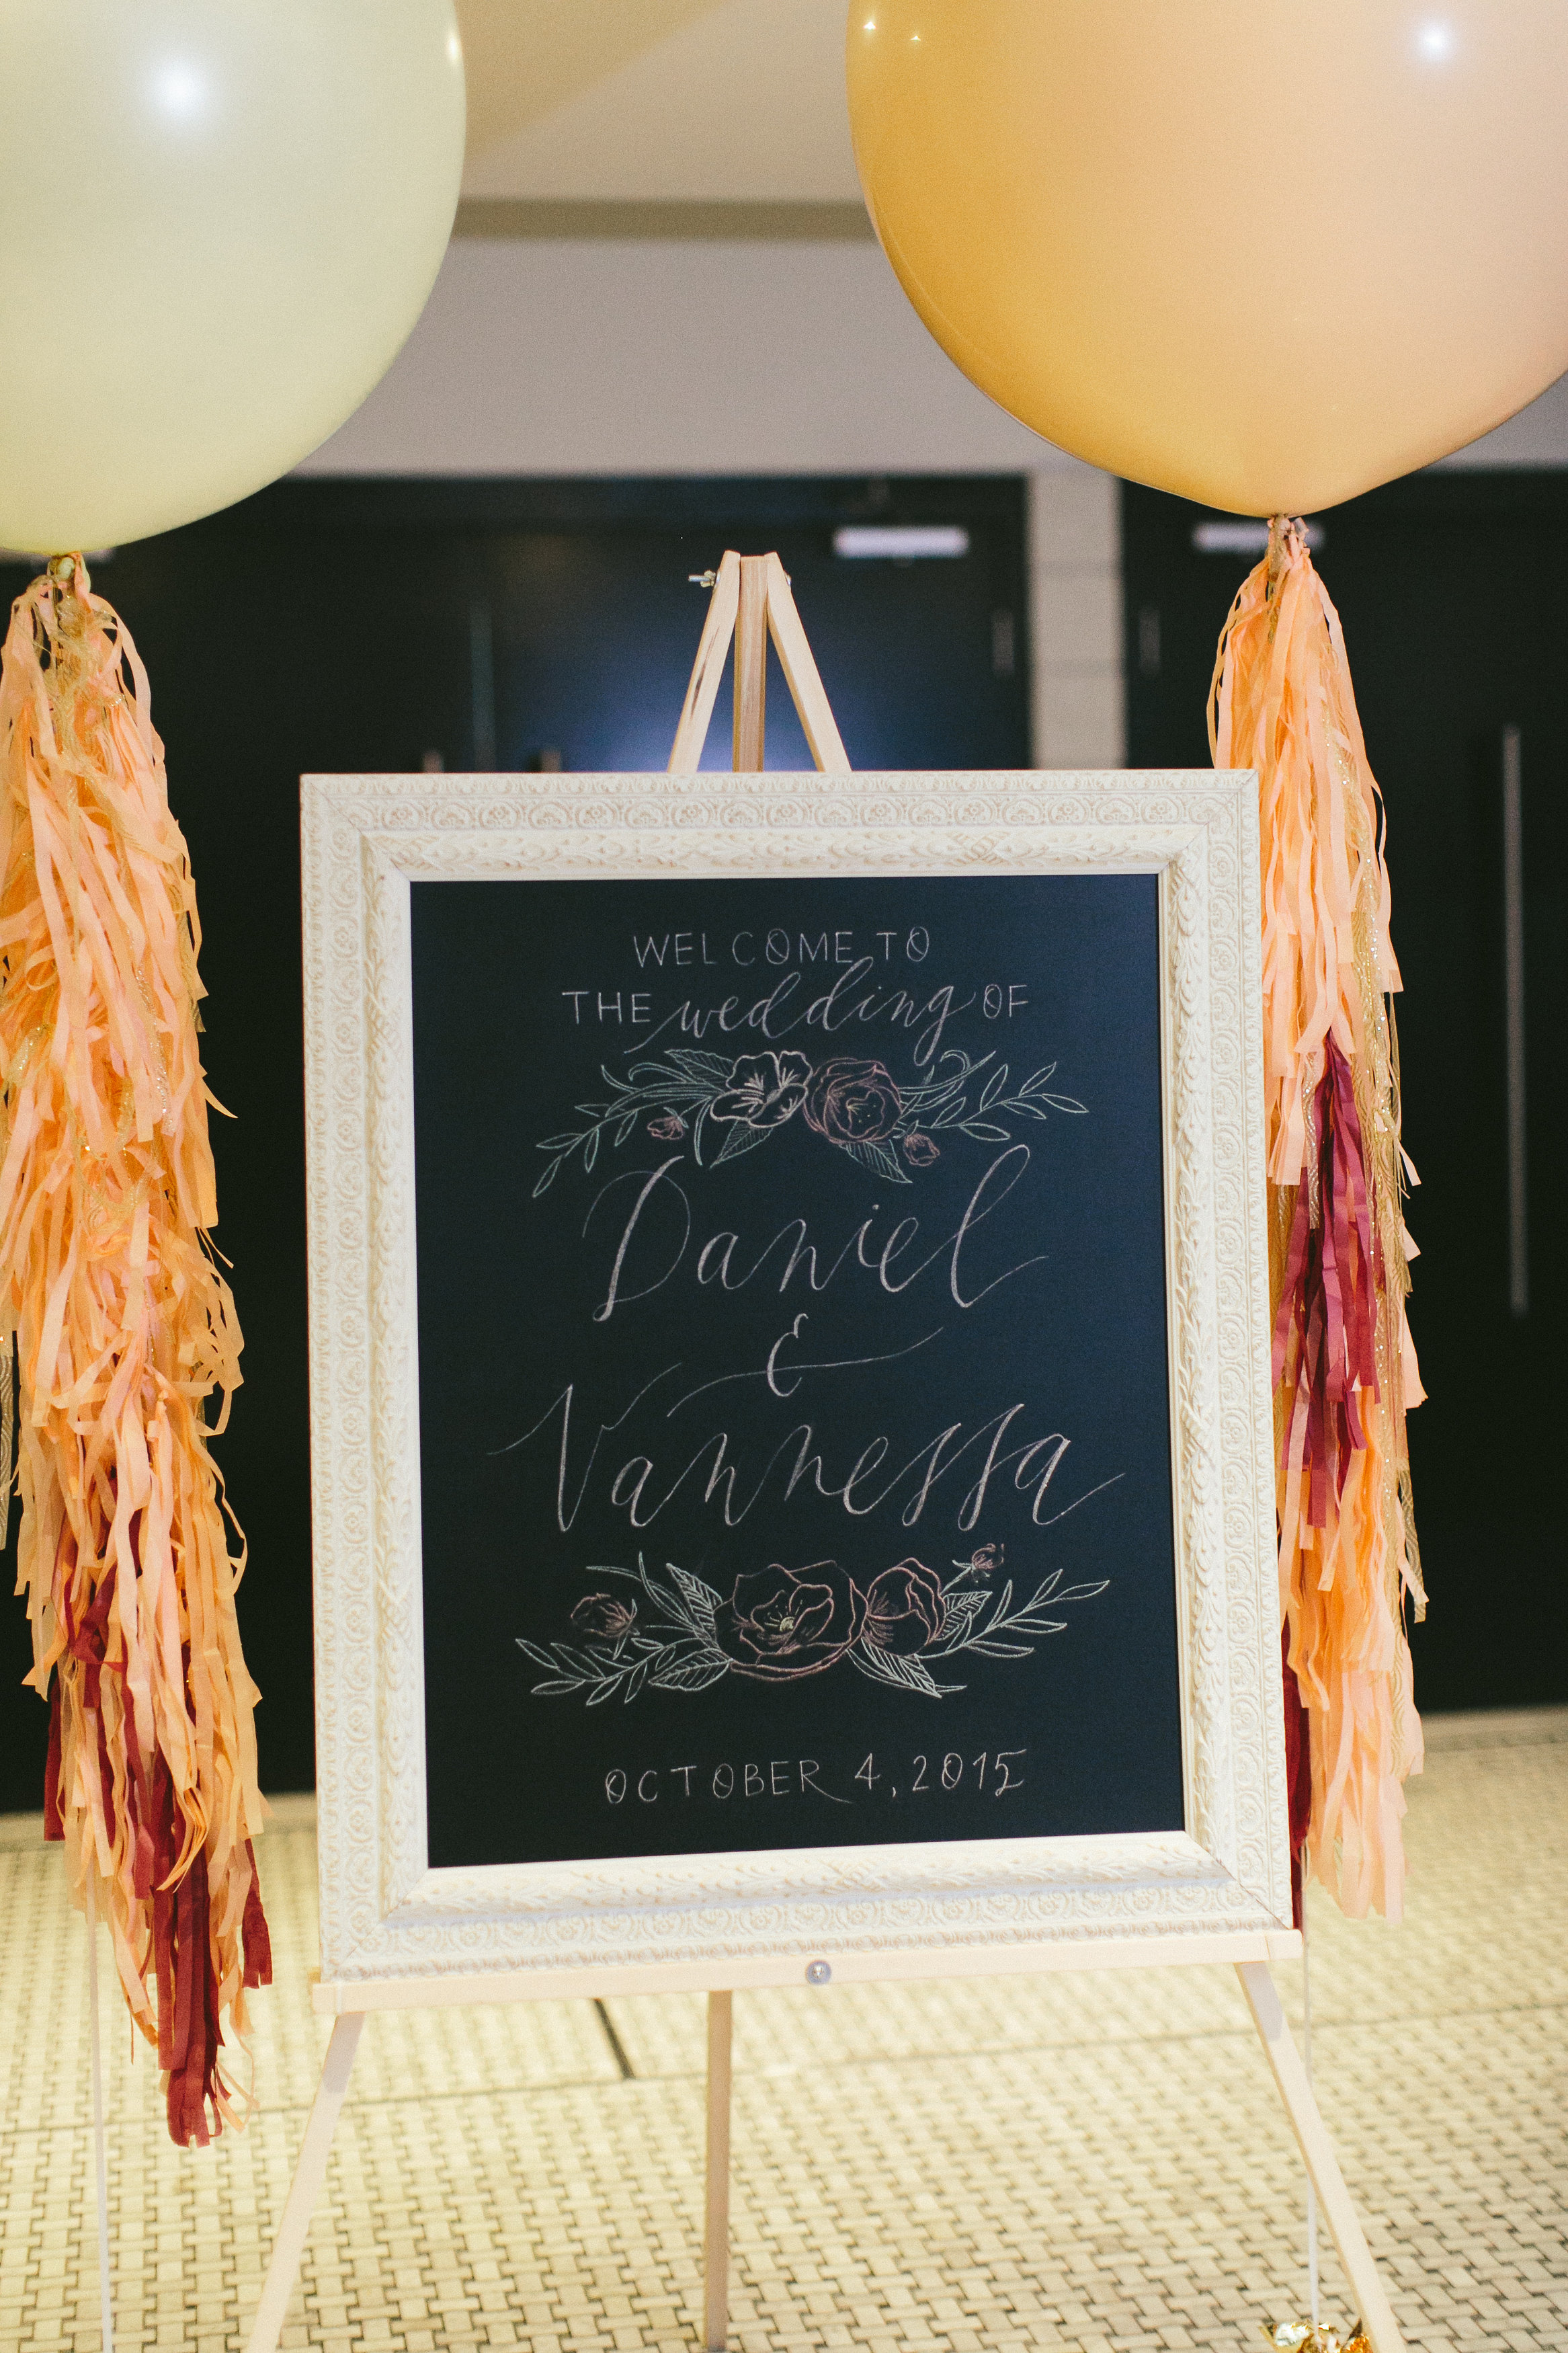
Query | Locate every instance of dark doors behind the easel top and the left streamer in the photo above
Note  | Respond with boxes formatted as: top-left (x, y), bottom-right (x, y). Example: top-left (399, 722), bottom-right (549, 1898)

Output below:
top-left (0, 478), bottom-right (1030, 1812)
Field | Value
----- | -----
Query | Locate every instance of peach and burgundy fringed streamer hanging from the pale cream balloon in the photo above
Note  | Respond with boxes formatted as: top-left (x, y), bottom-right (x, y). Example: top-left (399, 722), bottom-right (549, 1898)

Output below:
top-left (0, 555), bottom-right (273, 2146)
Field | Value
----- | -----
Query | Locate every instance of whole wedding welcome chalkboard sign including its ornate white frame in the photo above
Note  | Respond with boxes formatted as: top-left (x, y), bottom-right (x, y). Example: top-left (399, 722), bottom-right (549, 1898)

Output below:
top-left (300, 774), bottom-right (1290, 1986)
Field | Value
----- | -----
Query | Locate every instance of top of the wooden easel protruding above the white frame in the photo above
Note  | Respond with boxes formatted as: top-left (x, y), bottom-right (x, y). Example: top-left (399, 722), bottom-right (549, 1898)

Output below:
top-left (670, 549), bottom-right (849, 776)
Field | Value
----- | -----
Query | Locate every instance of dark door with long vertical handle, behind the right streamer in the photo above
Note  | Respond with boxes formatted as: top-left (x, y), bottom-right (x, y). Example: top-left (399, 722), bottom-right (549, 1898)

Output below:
top-left (1124, 473), bottom-right (1568, 1708)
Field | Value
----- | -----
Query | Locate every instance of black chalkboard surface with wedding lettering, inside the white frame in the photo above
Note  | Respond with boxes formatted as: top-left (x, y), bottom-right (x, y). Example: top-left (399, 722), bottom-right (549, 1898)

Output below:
top-left (411, 873), bottom-right (1182, 1866)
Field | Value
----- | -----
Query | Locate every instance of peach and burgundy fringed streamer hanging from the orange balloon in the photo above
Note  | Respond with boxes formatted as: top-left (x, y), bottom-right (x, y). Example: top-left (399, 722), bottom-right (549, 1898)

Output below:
top-left (1208, 516), bottom-right (1427, 1920)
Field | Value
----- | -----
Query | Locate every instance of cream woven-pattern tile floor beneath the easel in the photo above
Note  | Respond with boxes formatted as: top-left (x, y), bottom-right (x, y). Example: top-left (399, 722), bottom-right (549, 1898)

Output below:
top-left (0, 1711), bottom-right (1568, 2353)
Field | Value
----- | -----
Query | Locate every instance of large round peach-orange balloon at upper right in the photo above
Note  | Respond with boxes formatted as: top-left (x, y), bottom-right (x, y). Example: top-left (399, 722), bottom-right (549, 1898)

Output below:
top-left (849, 0), bottom-right (1568, 516)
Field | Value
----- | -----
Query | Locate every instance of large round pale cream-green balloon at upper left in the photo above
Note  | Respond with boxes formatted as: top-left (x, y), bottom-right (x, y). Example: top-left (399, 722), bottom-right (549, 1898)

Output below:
top-left (0, 0), bottom-right (463, 553)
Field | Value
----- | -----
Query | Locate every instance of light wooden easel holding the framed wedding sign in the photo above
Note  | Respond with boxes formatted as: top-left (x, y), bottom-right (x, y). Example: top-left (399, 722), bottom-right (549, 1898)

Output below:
top-left (247, 565), bottom-right (1406, 2353)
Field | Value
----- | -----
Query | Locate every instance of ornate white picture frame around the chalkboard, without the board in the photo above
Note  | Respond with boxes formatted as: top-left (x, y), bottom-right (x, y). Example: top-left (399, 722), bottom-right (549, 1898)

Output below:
top-left (303, 772), bottom-right (1298, 2009)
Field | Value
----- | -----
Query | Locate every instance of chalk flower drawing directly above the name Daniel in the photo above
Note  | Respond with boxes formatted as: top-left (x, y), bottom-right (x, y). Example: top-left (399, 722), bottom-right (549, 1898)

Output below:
top-left (534, 1047), bottom-right (1083, 1200)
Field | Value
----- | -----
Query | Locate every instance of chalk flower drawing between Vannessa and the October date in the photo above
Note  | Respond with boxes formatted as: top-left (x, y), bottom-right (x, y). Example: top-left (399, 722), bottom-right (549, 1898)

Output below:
top-left (515, 1544), bottom-right (1110, 1708)
